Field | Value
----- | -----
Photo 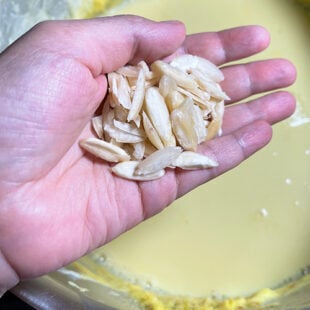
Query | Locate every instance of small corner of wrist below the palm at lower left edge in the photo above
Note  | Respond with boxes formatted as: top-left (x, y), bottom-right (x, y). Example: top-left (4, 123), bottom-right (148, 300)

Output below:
top-left (0, 250), bottom-right (19, 298)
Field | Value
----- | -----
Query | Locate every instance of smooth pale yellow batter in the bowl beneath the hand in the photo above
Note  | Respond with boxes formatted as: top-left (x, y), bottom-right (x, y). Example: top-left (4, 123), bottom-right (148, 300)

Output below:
top-left (53, 0), bottom-right (310, 309)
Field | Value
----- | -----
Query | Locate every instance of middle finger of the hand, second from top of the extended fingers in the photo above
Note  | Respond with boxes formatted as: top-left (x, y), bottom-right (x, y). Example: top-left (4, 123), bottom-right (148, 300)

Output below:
top-left (221, 59), bottom-right (296, 103)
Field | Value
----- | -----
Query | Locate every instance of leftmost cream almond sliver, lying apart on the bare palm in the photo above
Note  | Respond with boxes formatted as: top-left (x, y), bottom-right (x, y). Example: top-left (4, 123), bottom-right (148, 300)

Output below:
top-left (80, 138), bottom-right (130, 162)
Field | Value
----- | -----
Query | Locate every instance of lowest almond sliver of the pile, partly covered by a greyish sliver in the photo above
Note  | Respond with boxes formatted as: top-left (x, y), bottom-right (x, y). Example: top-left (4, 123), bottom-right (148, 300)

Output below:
top-left (112, 160), bottom-right (165, 181)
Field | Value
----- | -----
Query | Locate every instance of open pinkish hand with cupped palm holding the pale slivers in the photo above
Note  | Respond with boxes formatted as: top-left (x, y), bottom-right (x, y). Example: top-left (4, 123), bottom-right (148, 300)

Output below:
top-left (0, 16), bottom-right (296, 294)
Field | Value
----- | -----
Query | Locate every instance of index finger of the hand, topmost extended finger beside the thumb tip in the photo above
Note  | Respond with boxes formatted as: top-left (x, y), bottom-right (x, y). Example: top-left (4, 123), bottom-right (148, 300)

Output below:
top-left (178, 26), bottom-right (270, 65)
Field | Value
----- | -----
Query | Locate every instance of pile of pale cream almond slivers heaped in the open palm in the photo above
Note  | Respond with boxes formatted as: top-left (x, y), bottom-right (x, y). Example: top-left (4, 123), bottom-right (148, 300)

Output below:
top-left (80, 54), bottom-right (229, 181)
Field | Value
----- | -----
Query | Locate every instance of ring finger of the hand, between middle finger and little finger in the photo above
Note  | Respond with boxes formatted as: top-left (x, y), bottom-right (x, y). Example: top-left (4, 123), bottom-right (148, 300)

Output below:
top-left (222, 91), bottom-right (296, 135)
